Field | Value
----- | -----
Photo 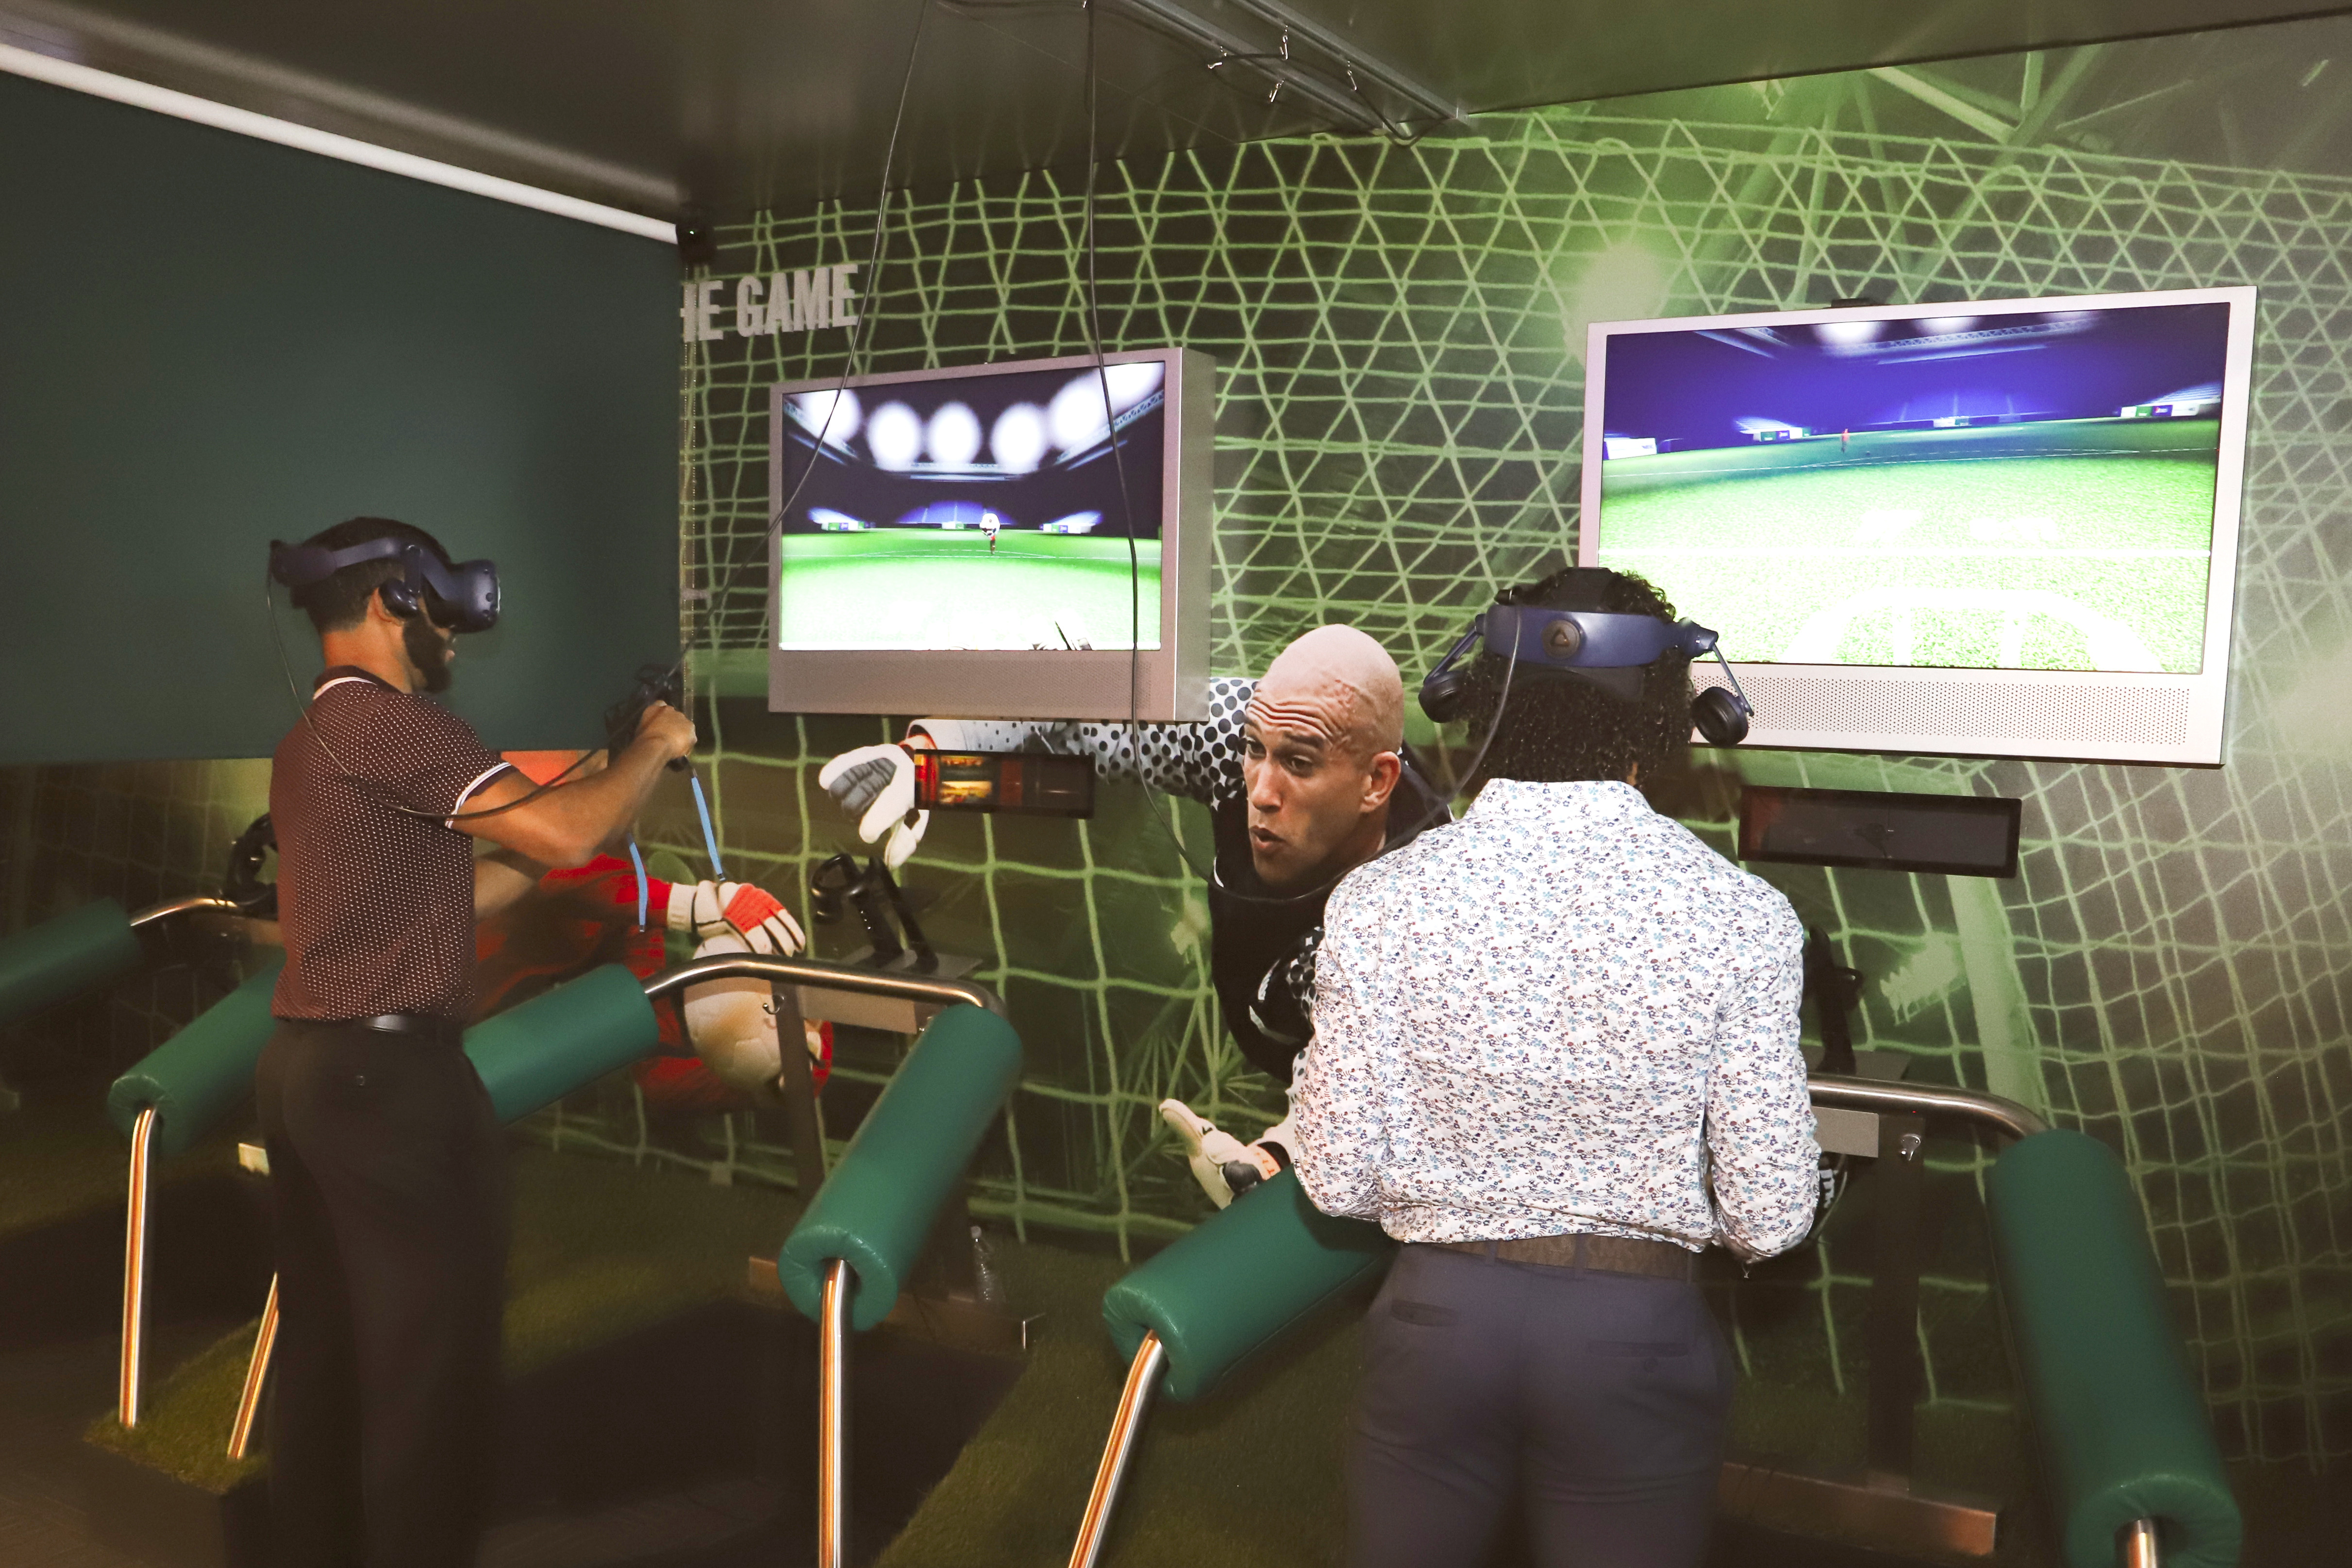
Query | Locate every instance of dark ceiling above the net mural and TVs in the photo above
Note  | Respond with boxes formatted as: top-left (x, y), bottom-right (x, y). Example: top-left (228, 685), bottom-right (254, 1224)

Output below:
top-left (0, 0), bottom-right (2352, 218)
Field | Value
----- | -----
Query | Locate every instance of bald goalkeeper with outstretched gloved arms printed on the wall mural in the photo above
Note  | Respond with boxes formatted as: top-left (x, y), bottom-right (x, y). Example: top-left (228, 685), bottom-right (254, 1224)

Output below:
top-left (816, 625), bottom-right (1447, 1208)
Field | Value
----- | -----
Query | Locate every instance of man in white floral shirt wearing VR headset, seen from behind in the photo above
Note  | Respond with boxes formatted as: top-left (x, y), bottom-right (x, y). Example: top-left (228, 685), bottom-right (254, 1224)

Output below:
top-left (1291, 569), bottom-right (1818, 1568)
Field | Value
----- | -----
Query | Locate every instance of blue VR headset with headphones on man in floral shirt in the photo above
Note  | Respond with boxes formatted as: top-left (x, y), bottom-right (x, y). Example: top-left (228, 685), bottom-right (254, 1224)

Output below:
top-left (1420, 602), bottom-right (1754, 745)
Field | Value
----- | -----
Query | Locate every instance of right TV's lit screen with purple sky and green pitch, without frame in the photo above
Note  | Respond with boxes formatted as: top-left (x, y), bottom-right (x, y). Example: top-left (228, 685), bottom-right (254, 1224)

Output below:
top-left (1585, 301), bottom-right (2230, 675)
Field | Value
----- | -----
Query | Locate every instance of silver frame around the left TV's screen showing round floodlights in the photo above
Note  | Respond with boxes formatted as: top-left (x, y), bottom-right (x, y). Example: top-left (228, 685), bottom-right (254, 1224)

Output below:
top-left (767, 348), bottom-right (1216, 722)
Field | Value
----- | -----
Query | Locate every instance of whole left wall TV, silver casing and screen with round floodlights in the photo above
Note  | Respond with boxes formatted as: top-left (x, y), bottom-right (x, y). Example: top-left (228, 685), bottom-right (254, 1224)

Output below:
top-left (767, 348), bottom-right (1216, 719)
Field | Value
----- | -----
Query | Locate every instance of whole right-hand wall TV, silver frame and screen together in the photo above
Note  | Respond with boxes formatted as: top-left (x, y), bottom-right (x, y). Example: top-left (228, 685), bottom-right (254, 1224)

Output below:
top-left (1578, 289), bottom-right (2253, 764)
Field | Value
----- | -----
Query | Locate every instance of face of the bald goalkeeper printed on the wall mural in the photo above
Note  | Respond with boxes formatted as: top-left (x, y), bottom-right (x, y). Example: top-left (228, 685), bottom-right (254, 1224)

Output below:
top-left (1242, 665), bottom-right (1402, 893)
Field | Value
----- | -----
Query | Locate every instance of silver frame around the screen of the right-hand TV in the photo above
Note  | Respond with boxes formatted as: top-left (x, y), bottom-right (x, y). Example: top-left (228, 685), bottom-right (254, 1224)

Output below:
top-left (1576, 287), bottom-right (2255, 767)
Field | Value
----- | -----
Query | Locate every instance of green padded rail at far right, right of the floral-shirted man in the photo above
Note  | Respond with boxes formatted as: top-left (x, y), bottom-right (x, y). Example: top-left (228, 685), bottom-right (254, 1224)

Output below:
top-left (1985, 1131), bottom-right (2241, 1568)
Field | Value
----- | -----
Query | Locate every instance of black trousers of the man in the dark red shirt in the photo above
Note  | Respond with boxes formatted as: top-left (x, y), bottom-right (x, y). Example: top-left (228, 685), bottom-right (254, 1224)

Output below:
top-left (254, 1020), bottom-right (506, 1568)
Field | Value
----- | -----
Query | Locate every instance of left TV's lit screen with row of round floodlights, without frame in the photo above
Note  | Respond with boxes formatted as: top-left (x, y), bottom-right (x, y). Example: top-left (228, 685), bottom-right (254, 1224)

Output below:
top-left (771, 362), bottom-right (1167, 651)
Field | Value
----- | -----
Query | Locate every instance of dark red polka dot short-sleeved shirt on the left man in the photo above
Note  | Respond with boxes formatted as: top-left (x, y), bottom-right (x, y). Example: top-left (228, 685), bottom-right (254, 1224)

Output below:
top-left (270, 665), bottom-right (508, 1020)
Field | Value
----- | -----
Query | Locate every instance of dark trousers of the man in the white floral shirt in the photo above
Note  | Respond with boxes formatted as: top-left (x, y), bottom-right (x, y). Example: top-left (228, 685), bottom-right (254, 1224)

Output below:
top-left (1348, 1246), bottom-right (1731, 1568)
